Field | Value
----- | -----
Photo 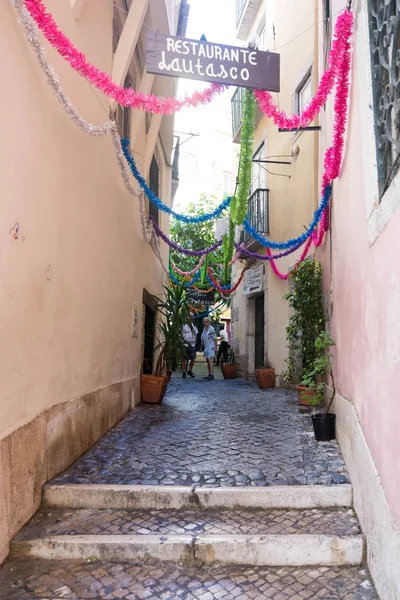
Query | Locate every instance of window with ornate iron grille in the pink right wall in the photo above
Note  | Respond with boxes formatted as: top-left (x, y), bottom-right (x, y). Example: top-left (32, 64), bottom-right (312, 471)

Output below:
top-left (368, 0), bottom-right (400, 199)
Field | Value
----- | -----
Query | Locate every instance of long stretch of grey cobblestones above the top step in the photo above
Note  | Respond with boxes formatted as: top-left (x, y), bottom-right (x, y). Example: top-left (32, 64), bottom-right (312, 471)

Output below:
top-left (54, 374), bottom-right (349, 487)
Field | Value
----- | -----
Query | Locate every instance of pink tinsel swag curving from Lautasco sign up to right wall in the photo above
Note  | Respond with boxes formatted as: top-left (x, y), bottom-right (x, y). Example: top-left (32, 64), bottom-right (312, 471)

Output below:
top-left (254, 10), bottom-right (353, 129)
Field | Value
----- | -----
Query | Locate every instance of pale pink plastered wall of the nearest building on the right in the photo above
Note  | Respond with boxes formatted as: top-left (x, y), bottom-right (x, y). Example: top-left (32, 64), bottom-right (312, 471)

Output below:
top-left (319, 0), bottom-right (400, 600)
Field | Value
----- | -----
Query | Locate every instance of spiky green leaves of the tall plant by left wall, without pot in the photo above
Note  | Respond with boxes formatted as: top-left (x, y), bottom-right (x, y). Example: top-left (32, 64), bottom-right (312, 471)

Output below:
top-left (155, 284), bottom-right (190, 375)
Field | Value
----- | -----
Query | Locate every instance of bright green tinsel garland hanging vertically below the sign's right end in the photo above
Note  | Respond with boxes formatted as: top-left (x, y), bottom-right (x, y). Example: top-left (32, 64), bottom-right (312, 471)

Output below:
top-left (231, 89), bottom-right (256, 225)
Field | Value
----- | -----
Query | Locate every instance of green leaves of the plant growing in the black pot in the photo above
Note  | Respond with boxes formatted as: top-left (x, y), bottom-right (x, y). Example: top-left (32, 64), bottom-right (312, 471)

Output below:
top-left (301, 331), bottom-right (336, 414)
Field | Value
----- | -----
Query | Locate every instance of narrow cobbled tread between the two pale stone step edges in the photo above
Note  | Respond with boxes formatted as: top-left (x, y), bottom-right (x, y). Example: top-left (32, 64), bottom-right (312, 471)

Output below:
top-left (17, 509), bottom-right (360, 540)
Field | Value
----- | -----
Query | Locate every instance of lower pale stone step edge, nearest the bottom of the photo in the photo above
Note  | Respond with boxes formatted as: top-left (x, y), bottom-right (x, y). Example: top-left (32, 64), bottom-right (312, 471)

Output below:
top-left (12, 534), bottom-right (364, 566)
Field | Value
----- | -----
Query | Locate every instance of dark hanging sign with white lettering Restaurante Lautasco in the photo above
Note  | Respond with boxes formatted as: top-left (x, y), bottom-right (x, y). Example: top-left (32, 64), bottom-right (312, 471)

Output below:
top-left (146, 32), bottom-right (280, 92)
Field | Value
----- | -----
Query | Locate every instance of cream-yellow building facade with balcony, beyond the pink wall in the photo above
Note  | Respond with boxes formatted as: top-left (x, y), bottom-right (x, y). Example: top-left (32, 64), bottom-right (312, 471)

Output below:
top-left (232, 0), bottom-right (319, 382)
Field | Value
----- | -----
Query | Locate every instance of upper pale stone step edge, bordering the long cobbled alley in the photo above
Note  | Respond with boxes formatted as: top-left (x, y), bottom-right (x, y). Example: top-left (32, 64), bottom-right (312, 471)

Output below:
top-left (43, 484), bottom-right (352, 510)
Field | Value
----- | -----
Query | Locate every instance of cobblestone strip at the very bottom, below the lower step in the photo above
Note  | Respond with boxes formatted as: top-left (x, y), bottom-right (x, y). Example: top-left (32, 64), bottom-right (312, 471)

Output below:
top-left (0, 561), bottom-right (378, 600)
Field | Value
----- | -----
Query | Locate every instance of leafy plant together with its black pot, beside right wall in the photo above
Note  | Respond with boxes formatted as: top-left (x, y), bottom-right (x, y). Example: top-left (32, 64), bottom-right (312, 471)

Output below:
top-left (301, 331), bottom-right (336, 442)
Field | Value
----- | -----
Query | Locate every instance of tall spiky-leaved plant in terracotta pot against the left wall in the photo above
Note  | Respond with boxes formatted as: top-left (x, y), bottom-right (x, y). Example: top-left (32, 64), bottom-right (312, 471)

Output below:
top-left (141, 284), bottom-right (189, 404)
